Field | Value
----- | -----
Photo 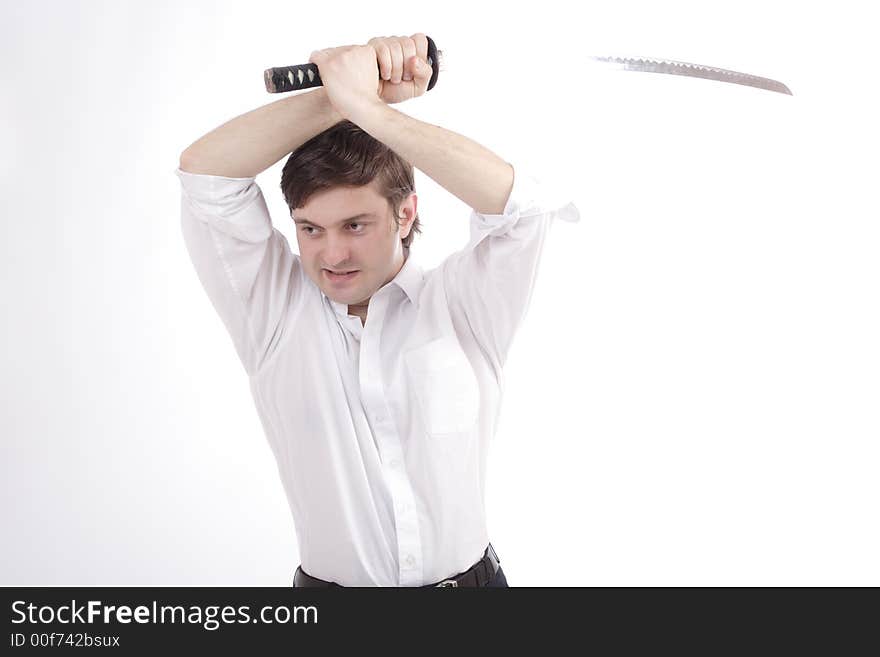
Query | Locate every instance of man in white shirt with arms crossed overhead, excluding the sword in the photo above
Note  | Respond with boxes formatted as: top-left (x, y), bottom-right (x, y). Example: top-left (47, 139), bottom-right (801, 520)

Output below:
top-left (177, 34), bottom-right (579, 587)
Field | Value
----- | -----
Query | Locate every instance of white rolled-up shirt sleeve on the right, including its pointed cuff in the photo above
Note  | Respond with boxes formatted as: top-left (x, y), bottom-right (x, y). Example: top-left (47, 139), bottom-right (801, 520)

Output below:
top-left (443, 166), bottom-right (580, 371)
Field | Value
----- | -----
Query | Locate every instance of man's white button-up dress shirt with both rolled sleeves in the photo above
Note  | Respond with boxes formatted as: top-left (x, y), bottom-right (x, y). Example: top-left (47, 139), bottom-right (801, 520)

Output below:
top-left (176, 161), bottom-right (580, 586)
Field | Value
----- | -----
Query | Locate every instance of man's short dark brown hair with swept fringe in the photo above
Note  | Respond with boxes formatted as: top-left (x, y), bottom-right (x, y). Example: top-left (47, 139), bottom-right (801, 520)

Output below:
top-left (281, 119), bottom-right (422, 251)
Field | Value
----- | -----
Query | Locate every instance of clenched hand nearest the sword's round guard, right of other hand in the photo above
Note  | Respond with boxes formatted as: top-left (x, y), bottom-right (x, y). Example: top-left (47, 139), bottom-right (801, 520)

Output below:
top-left (367, 32), bottom-right (437, 105)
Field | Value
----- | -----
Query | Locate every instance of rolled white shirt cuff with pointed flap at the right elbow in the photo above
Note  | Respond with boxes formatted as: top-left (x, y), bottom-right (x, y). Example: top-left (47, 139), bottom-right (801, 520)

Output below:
top-left (471, 165), bottom-right (580, 235)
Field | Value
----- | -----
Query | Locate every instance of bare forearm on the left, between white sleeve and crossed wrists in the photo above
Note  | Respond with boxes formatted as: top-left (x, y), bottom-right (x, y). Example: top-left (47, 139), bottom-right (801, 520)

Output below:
top-left (180, 88), bottom-right (342, 178)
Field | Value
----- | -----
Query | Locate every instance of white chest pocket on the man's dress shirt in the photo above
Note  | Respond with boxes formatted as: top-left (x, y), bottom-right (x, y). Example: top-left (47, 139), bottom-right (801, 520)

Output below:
top-left (404, 337), bottom-right (480, 435)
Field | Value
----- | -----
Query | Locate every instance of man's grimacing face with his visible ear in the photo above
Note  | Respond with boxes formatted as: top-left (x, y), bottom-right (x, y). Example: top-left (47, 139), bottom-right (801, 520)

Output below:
top-left (292, 181), bottom-right (417, 310)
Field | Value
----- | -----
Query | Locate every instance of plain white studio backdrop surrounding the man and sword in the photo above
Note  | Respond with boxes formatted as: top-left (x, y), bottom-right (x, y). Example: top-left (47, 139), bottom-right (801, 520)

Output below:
top-left (0, 0), bottom-right (880, 586)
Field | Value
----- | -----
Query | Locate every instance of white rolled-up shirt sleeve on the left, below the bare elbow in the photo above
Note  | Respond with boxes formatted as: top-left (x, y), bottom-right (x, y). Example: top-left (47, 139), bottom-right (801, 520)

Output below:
top-left (175, 168), bottom-right (302, 376)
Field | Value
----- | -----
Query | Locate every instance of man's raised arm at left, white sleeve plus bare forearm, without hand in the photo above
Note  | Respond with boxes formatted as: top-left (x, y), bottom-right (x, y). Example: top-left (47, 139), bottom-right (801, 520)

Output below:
top-left (177, 80), bottom-right (342, 375)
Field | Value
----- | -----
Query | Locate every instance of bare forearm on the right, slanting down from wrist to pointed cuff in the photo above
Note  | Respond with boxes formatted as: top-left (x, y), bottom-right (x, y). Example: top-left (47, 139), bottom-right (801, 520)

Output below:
top-left (349, 103), bottom-right (514, 214)
